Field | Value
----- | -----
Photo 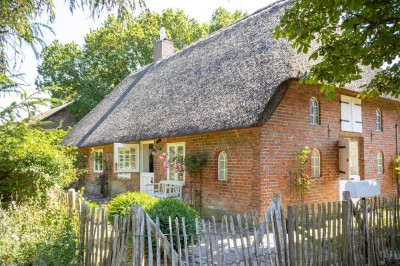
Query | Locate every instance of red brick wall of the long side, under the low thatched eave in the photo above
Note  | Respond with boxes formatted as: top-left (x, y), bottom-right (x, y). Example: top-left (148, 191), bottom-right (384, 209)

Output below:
top-left (81, 128), bottom-right (259, 211)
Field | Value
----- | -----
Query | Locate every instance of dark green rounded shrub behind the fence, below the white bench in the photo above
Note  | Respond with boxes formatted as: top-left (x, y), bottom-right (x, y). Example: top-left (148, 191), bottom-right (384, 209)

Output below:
top-left (147, 199), bottom-right (200, 239)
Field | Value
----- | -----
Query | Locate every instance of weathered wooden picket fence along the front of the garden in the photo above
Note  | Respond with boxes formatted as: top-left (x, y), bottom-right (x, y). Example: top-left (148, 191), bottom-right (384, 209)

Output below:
top-left (57, 190), bottom-right (400, 265)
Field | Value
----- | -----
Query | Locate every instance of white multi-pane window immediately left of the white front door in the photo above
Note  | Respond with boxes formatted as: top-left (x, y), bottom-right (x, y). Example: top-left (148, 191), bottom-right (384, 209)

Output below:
top-left (114, 143), bottom-right (139, 173)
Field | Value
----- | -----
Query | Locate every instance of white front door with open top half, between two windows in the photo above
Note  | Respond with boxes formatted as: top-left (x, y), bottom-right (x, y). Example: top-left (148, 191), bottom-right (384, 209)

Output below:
top-left (140, 141), bottom-right (155, 192)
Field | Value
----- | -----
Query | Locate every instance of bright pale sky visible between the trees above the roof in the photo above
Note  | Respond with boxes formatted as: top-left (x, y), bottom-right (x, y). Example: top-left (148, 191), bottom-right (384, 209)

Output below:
top-left (0, 0), bottom-right (275, 111)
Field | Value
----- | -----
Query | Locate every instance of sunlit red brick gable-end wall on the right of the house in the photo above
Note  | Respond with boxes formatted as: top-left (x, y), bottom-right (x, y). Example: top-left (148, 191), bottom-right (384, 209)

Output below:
top-left (260, 81), bottom-right (399, 207)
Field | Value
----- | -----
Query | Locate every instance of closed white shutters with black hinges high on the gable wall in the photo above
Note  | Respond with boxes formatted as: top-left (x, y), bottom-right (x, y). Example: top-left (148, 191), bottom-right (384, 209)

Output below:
top-left (340, 95), bottom-right (362, 133)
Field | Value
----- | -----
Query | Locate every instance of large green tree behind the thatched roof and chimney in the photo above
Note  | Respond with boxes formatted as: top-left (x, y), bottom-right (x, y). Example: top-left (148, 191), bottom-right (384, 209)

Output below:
top-left (36, 9), bottom-right (244, 120)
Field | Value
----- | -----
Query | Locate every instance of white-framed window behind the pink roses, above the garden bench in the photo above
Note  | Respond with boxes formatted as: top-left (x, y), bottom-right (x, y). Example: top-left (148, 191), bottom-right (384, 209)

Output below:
top-left (167, 142), bottom-right (185, 182)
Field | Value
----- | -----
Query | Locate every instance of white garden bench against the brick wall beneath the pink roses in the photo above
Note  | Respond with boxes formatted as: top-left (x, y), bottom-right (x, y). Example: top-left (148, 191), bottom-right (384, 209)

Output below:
top-left (145, 180), bottom-right (183, 199)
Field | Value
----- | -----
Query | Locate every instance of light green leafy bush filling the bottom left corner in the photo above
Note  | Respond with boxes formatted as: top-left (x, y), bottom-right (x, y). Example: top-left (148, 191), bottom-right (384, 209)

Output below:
top-left (0, 196), bottom-right (78, 265)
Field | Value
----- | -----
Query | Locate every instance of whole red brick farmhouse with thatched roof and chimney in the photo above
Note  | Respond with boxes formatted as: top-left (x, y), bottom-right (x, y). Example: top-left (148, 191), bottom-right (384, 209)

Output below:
top-left (64, 1), bottom-right (400, 212)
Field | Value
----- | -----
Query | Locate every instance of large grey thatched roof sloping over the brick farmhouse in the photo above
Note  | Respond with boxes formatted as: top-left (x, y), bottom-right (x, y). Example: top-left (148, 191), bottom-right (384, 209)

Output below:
top-left (63, 1), bottom-right (378, 147)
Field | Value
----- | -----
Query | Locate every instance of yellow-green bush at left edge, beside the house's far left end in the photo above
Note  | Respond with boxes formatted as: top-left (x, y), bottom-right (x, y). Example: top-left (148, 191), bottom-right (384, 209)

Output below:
top-left (0, 122), bottom-right (77, 200)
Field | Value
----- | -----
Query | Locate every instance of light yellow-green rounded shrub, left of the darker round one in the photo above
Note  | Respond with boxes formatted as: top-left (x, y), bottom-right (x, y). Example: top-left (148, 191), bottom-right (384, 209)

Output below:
top-left (107, 192), bottom-right (158, 221)
